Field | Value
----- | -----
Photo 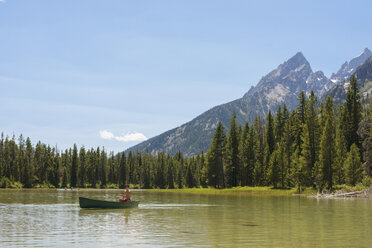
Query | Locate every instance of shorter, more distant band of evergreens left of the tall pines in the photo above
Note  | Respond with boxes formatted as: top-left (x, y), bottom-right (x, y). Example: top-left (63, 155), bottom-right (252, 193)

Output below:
top-left (0, 134), bottom-right (206, 188)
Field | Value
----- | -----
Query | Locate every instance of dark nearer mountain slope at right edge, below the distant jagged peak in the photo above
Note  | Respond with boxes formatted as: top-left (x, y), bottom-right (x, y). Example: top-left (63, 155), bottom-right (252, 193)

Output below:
top-left (323, 57), bottom-right (372, 104)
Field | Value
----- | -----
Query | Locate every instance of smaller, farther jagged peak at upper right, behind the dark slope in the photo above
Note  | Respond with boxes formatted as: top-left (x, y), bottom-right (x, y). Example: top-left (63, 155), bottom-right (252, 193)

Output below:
top-left (330, 48), bottom-right (372, 84)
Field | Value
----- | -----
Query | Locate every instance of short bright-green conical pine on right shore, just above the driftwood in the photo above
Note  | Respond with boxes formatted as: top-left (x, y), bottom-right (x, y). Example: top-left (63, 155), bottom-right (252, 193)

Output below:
top-left (344, 144), bottom-right (363, 186)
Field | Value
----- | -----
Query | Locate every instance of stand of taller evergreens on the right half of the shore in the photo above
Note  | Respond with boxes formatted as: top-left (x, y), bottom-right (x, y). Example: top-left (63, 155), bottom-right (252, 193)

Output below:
top-left (206, 77), bottom-right (372, 191)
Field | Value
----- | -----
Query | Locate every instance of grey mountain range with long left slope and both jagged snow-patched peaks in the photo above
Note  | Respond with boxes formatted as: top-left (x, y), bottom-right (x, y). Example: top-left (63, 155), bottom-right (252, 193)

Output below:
top-left (126, 48), bottom-right (371, 156)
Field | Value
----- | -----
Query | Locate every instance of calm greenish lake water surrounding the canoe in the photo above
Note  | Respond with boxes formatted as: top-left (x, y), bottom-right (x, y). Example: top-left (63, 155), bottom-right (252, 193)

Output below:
top-left (0, 190), bottom-right (372, 248)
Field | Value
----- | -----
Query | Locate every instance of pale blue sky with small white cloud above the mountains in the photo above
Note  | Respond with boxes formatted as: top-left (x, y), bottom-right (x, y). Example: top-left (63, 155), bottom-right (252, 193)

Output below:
top-left (0, 0), bottom-right (372, 152)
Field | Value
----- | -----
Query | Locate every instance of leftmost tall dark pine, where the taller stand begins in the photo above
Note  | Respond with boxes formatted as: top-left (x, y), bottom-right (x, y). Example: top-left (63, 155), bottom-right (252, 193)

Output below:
top-left (206, 122), bottom-right (226, 188)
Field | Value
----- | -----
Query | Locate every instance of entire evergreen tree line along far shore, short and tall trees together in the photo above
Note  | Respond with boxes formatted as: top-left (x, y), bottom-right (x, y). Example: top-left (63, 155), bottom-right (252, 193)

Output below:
top-left (0, 77), bottom-right (372, 191)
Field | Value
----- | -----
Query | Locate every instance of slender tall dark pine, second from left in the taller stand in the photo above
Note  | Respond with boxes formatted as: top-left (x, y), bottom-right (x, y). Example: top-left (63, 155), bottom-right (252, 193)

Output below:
top-left (223, 112), bottom-right (240, 187)
